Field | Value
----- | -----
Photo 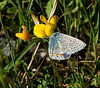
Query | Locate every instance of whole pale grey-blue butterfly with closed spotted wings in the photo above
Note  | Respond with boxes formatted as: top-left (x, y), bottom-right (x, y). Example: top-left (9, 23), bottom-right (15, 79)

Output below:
top-left (48, 32), bottom-right (86, 60)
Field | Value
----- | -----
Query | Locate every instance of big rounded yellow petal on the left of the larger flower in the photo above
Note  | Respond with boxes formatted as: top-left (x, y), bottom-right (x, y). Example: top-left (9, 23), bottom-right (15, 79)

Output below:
top-left (33, 24), bottom-right (47, 38)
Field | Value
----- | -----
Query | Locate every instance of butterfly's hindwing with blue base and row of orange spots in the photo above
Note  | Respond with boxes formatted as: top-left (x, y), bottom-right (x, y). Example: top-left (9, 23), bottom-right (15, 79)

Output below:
top-left (48, 32), bottom-right (71, 60)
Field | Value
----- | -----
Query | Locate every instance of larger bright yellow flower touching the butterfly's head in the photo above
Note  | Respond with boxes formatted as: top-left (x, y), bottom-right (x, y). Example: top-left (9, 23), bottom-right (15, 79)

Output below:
top-left (33, 15), bottom-right (59, 38)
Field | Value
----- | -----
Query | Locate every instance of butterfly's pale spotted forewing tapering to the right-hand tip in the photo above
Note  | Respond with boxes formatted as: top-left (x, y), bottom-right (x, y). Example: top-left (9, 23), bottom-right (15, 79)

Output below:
top-left (60, 33), bottom-right (86, 54)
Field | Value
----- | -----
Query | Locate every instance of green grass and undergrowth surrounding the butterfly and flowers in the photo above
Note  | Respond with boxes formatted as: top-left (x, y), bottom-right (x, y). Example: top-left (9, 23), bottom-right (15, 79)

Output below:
top-left (0, 0), bottom-right (100, 88)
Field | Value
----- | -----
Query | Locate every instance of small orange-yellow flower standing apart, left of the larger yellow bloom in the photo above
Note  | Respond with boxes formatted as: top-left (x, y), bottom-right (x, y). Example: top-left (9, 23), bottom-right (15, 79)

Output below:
top-left (15, 25), bottom-right (32, 41)
